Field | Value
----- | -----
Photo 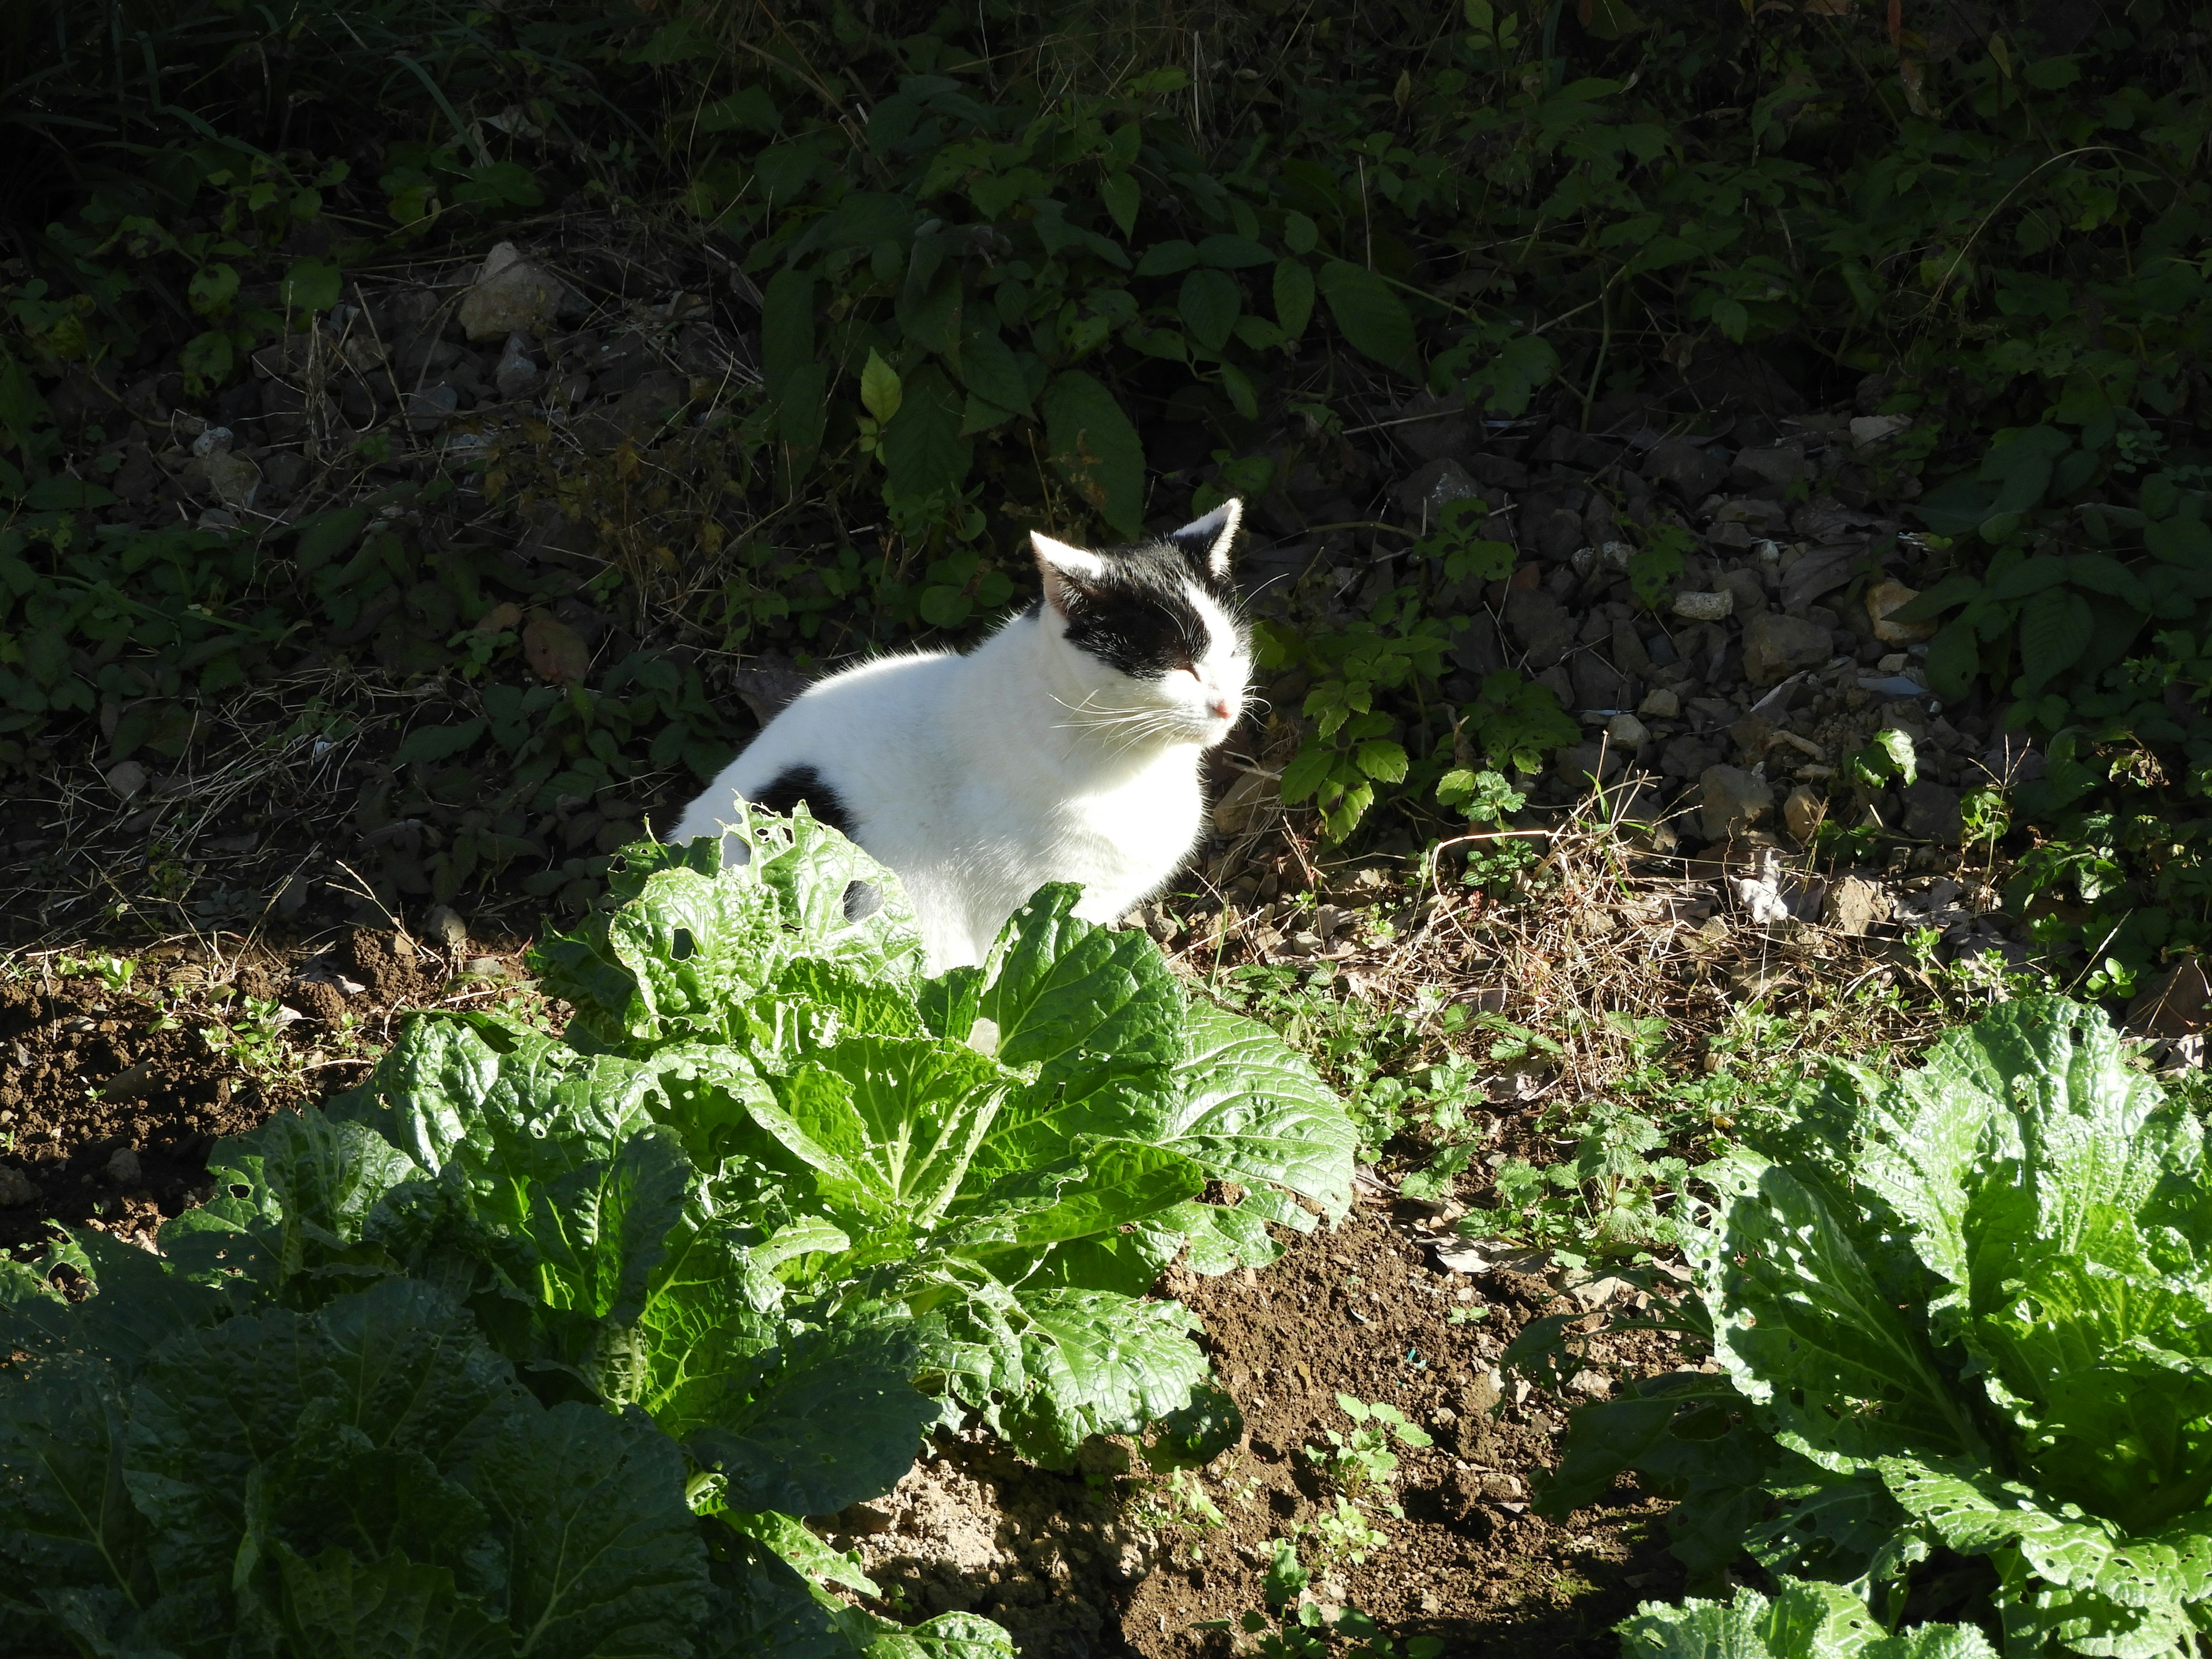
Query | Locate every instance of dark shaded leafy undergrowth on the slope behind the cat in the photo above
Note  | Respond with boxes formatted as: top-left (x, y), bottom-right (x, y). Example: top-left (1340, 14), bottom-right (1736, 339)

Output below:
top-left (0, 0), bottom-right (2212, 991)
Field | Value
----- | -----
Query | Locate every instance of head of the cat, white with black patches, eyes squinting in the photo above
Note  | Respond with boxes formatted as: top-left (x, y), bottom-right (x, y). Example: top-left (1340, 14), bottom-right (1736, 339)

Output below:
top-left (1031, 500), bottom-right (1252, 748)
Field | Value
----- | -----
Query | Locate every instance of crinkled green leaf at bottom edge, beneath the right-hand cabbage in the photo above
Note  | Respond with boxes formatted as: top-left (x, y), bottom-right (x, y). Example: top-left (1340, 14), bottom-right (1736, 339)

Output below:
top-left (1619, 1577), bottom-right (1995, 1659)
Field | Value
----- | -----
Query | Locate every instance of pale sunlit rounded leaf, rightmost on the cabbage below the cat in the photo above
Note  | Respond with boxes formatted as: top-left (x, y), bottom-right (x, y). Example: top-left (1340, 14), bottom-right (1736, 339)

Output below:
top-left (1161, 1002), bottom-right (1358, 1232)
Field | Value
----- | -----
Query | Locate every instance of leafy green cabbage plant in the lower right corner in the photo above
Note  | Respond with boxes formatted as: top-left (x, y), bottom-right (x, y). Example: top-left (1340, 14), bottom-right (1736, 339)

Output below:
top-left (1544, 998), bottom-right (2212, 1654)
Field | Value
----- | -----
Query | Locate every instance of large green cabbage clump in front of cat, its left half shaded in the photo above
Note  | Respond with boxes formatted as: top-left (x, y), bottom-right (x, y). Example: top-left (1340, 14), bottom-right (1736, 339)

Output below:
top-left (0, 816), bottom-right (1354, 1659)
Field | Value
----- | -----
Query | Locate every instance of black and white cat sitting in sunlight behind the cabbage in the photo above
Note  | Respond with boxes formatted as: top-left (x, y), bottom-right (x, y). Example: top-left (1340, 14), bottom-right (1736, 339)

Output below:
top-left (672, 500), bottom-right (1252, 974)
